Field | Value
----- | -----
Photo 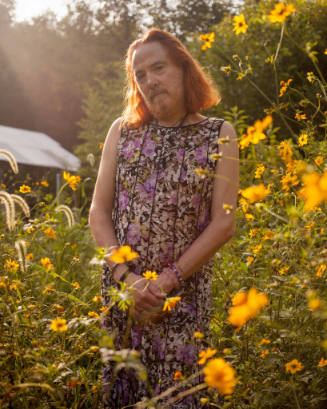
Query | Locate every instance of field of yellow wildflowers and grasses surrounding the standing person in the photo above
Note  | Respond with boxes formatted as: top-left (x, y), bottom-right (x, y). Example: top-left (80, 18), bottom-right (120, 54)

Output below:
top-left (0, 0), bottom-right (327, 409)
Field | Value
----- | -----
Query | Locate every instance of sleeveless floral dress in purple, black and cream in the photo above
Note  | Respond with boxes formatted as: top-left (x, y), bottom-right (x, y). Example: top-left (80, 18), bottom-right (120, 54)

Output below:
top-left (102, 118), bottom-right (223, 409)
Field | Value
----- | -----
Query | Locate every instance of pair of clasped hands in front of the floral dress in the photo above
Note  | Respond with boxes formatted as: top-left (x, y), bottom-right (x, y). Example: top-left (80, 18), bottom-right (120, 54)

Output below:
top-left (126, 268), bottom-right (178, 324)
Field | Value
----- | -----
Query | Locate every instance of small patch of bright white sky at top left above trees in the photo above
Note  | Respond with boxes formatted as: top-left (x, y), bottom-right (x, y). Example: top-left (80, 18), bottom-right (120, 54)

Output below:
top-left (16, 0), bottom-right (69, 21)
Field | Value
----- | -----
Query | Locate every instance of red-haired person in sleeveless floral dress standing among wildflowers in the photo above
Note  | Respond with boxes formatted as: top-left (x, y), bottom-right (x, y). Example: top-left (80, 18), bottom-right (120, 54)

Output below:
top-left (89, 29), bottom-right (238, 409)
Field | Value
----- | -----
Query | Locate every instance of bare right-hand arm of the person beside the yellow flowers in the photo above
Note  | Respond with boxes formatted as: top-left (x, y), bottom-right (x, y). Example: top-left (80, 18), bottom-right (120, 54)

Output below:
top-left (158, 122), bottom-right (239, 292)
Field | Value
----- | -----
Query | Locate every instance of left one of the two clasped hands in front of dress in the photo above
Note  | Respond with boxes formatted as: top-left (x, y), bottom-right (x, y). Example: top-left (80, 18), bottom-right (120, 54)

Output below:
top-left (126, 273), bottom-right (166, 317)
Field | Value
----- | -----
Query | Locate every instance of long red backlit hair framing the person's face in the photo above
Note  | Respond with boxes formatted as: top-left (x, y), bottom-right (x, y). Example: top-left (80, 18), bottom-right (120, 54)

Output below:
top-left (122, 29), bottom-right (220, 128)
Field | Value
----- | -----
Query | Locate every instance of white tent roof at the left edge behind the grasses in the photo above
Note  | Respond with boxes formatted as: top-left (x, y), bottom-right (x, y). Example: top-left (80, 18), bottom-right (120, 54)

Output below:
top-left (0, 125), bottom-right (80, 171)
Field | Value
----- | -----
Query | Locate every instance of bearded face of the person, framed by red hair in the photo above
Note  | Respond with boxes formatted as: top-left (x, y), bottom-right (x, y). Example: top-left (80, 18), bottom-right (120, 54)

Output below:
top-left (132, 41), bottom-right (186, 124)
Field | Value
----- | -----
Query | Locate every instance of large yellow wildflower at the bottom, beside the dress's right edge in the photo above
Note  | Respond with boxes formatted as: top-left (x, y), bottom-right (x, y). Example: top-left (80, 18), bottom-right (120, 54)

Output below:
top-left (203, 358), bottom-right (236, 395)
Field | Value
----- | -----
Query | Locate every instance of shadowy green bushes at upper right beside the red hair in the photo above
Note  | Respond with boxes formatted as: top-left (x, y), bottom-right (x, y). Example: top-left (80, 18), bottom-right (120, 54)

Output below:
top-left (190, 0), bottom-right (327, 137)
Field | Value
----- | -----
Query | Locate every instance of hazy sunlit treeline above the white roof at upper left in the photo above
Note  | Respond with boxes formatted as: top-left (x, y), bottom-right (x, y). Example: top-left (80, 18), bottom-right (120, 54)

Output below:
top-left (0, 0), bottom-right (229, 150)
